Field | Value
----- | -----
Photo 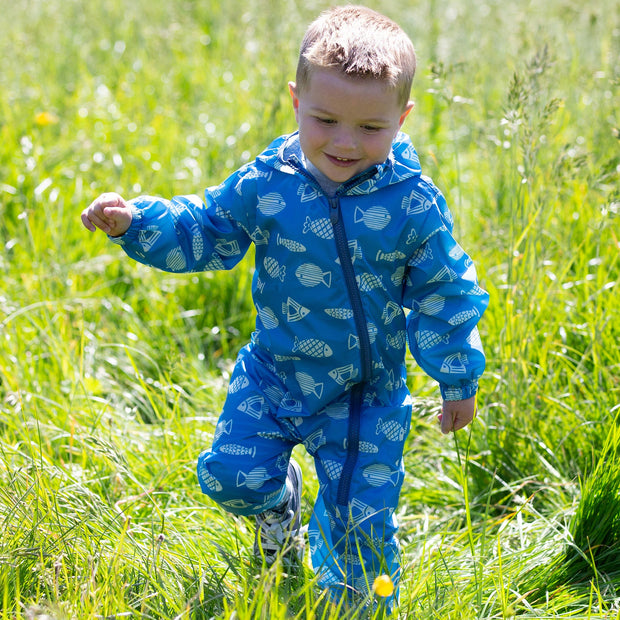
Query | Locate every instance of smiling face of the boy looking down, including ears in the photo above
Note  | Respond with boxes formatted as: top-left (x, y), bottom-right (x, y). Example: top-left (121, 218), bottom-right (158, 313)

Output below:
top-left (289, 68), bottom-right (413, 183)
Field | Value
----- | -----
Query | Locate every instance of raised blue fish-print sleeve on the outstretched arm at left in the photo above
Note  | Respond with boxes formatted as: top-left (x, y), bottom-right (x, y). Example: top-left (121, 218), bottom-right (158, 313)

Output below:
top-left (111, 166), bottom-right (256, 273)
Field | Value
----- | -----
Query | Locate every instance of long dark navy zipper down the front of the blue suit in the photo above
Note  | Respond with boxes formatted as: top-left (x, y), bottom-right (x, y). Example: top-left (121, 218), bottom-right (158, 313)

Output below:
top-left (329, 197), bottom-right (372, 506)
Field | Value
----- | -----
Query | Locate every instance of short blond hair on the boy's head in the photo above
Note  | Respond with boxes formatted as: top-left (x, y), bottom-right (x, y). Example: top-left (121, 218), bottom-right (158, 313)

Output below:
top-left (296, 5), bottom-right (416, 108)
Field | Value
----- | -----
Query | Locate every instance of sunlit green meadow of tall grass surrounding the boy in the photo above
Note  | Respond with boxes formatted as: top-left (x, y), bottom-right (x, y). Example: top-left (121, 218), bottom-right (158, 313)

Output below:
top-left (0, 0), bottom-right (620, 620)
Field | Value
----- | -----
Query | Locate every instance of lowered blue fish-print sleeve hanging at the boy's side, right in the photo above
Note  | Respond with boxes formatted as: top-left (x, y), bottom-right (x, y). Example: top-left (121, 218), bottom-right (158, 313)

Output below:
top-left (403, 194), bottom-right (489, 400)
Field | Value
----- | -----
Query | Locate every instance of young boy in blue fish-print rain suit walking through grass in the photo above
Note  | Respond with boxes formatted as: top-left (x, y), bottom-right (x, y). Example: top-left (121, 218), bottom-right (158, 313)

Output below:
top-left (82, 6), bottom-right (488, 612)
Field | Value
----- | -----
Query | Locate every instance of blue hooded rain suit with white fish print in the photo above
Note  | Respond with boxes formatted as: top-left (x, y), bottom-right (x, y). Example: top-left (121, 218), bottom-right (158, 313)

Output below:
top-left (110, 133), bottom-right (488, 591)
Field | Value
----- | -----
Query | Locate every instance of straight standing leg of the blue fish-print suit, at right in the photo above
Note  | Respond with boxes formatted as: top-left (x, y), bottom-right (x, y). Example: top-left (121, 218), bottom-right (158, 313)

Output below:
top-left (302, 390), bottom-right (411, 604)
